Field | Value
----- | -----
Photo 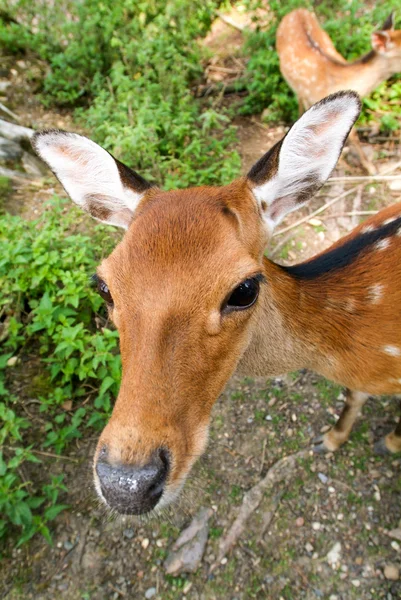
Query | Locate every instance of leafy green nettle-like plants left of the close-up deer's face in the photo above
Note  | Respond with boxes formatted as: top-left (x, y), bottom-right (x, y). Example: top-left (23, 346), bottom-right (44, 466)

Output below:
top-left (0, 198), bottom-right (121, 544)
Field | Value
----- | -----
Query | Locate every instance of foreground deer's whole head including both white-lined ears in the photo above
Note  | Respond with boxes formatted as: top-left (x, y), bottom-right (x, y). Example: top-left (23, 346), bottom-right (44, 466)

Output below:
top-left (34, 93), bottom-right (359, 514)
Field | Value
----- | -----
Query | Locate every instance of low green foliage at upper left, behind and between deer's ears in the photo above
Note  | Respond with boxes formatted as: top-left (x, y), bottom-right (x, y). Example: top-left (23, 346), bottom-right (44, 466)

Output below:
top-left (0, 0), bottom-right (240, 188)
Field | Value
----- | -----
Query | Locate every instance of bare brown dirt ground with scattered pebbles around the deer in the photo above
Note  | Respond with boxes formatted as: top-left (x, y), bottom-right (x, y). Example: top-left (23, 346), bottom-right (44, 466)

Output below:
top-left (0, 12), bottom-right (401, 600)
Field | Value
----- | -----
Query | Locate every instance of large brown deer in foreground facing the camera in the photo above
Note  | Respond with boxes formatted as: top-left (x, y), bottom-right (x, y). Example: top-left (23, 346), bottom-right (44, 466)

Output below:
top-left (33, 91), bottom-right (401, 514)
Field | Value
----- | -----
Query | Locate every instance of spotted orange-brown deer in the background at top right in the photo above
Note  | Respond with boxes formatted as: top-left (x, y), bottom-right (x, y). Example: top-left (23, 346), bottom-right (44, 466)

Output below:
top-left (276, 8), bottom-right (401, 175)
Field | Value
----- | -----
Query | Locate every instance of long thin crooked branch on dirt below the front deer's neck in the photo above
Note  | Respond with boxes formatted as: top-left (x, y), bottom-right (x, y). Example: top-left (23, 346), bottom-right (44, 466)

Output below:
top-left (210, 450), bottom-right (310, 573)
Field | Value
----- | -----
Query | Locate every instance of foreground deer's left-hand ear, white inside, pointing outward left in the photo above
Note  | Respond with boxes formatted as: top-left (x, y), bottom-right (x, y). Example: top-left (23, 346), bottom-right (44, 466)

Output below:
top-left (32, 130), bottom-right (151, 229)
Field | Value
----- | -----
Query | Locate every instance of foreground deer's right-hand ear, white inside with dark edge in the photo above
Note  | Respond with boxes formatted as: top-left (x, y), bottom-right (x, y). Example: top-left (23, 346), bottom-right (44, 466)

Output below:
top-left (248, 91), bottom-right (361, 233)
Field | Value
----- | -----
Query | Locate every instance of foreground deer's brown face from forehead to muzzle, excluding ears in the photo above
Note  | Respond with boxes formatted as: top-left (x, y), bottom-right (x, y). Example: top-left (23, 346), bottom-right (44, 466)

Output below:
top-left (90, 181), bottom-right (265, 512)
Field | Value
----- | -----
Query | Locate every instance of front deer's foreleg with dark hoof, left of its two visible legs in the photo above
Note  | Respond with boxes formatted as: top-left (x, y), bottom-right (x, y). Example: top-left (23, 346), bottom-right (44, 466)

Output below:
top-left (314, 389), bottom-right (369, 452)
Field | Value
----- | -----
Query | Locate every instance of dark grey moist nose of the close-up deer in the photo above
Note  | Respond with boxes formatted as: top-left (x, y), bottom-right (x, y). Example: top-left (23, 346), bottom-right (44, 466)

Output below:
top-left (96, 448), bottom-right (170, 515)
